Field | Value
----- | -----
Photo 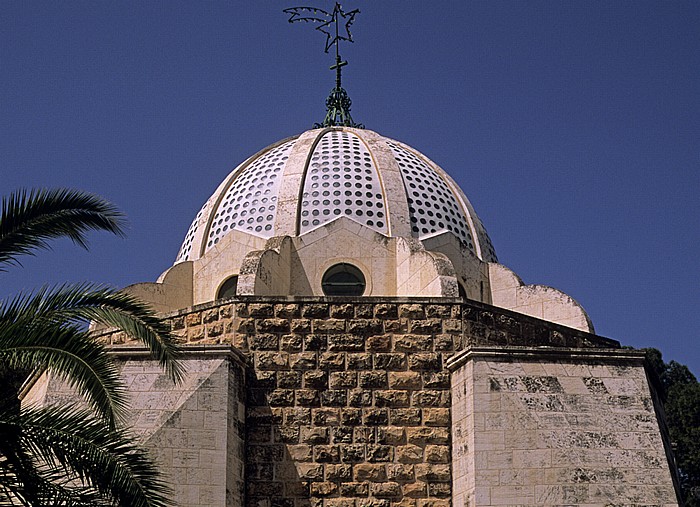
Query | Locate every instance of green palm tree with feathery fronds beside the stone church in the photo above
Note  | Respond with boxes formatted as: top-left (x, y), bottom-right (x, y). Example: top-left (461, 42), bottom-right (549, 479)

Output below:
top-left (0, 189), bottom-right (183, 507)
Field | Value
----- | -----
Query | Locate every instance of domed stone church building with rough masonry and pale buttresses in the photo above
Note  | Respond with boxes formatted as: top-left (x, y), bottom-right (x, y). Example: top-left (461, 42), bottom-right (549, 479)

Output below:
top-left (24, 127), bottom-right (679, 507)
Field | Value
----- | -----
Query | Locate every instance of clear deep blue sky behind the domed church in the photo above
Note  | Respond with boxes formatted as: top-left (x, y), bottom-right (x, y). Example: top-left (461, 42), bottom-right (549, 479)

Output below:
top-left (0, 0), bottom-right (700, 374)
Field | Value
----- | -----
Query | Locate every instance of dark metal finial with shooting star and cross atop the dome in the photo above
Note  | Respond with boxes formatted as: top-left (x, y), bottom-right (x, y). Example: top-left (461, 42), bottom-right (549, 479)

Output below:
top-left (284, 2), bottom-right (365, 128)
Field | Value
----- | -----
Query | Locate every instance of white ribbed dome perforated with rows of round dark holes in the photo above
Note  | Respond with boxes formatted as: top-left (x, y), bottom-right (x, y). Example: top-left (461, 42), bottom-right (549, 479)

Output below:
top-left (176, 127), bottom-right (496, 262)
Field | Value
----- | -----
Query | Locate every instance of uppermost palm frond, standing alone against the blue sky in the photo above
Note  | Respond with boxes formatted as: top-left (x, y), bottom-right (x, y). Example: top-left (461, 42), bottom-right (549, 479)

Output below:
top-left (0, 189), bottom-right (125, 271)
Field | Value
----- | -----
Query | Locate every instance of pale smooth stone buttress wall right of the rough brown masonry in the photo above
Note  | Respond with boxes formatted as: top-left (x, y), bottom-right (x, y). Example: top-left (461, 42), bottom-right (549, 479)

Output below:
top-left (449, 348), bottom-right (678, 507)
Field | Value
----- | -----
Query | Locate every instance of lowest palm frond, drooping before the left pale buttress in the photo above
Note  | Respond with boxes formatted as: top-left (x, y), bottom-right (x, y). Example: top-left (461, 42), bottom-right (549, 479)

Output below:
top-left (0, 407), bottom-right (172, 507)
